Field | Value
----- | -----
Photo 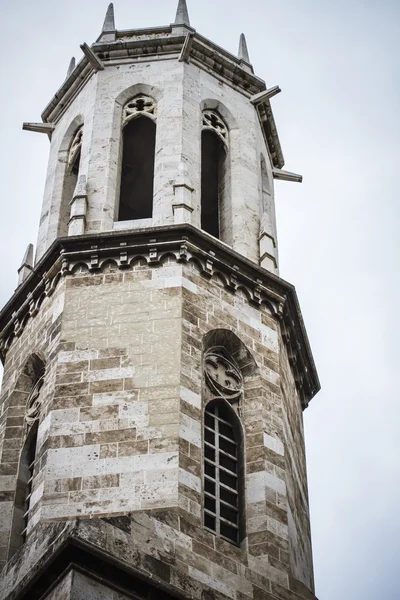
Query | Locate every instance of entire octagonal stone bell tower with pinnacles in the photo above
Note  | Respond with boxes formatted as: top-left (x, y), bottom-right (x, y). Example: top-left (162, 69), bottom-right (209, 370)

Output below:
top-left (0, 0), bottom-right (319, 600)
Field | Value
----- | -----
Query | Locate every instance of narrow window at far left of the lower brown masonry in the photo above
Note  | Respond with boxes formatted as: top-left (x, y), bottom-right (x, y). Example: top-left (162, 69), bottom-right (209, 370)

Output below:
top-left (10, 356), bottom-right (45, 557)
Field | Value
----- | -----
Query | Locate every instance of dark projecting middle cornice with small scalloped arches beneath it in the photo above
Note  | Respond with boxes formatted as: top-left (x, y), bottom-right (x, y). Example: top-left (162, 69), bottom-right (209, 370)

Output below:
top-left (0, 225), bottom-right (320, 408)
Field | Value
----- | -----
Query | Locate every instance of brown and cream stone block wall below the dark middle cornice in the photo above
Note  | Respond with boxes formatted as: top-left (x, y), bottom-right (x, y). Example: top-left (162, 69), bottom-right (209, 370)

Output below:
top-left (3, 256), bottom-right (312, 600)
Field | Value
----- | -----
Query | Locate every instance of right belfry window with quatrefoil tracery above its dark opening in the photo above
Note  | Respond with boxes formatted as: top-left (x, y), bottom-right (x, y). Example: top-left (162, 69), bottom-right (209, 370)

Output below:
top-left (201, 110), bottom-right (229, 239)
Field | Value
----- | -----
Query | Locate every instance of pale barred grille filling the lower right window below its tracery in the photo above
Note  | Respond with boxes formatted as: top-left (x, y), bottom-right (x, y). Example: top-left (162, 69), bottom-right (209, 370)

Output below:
top-left (204, 401), bottom-right (240, 544)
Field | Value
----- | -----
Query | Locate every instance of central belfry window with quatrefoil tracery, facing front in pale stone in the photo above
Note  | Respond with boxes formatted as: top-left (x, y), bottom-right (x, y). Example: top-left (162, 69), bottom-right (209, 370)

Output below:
top-left (118, 94), bottom-right (156, 221)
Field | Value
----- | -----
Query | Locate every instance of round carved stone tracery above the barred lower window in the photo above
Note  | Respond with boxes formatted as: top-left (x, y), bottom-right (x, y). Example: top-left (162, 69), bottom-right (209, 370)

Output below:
top-left (204, 347), bottom-right (243, 404)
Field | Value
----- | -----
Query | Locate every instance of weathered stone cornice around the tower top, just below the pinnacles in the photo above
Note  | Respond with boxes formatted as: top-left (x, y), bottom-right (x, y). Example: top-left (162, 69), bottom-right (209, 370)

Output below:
top-left (42, 25), bottom-right (284, 168)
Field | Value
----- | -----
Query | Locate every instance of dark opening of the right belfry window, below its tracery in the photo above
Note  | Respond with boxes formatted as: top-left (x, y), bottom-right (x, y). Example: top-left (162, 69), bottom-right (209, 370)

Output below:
top-left (201, 129), bottom-right (225, 239)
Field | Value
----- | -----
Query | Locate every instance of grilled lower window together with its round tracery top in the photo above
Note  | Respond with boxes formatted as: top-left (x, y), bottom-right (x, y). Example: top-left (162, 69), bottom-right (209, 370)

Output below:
top-left (203, 347), bottom-right (244, 545)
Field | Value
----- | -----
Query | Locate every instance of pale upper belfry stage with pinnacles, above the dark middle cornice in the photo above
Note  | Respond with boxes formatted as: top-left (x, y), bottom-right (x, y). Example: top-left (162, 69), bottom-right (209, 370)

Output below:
top-left (25, 1), bottom-right (296, 273)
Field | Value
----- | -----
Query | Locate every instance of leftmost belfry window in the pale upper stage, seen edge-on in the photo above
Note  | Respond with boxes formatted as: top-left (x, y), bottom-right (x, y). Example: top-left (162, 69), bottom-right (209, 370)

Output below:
top-left (58, 125), bottom-right (83, 236)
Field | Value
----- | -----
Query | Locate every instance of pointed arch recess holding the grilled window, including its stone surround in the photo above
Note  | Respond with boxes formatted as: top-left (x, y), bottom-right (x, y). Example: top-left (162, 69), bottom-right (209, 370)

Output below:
top-left (203, 329), bottom-right (260, 546)
